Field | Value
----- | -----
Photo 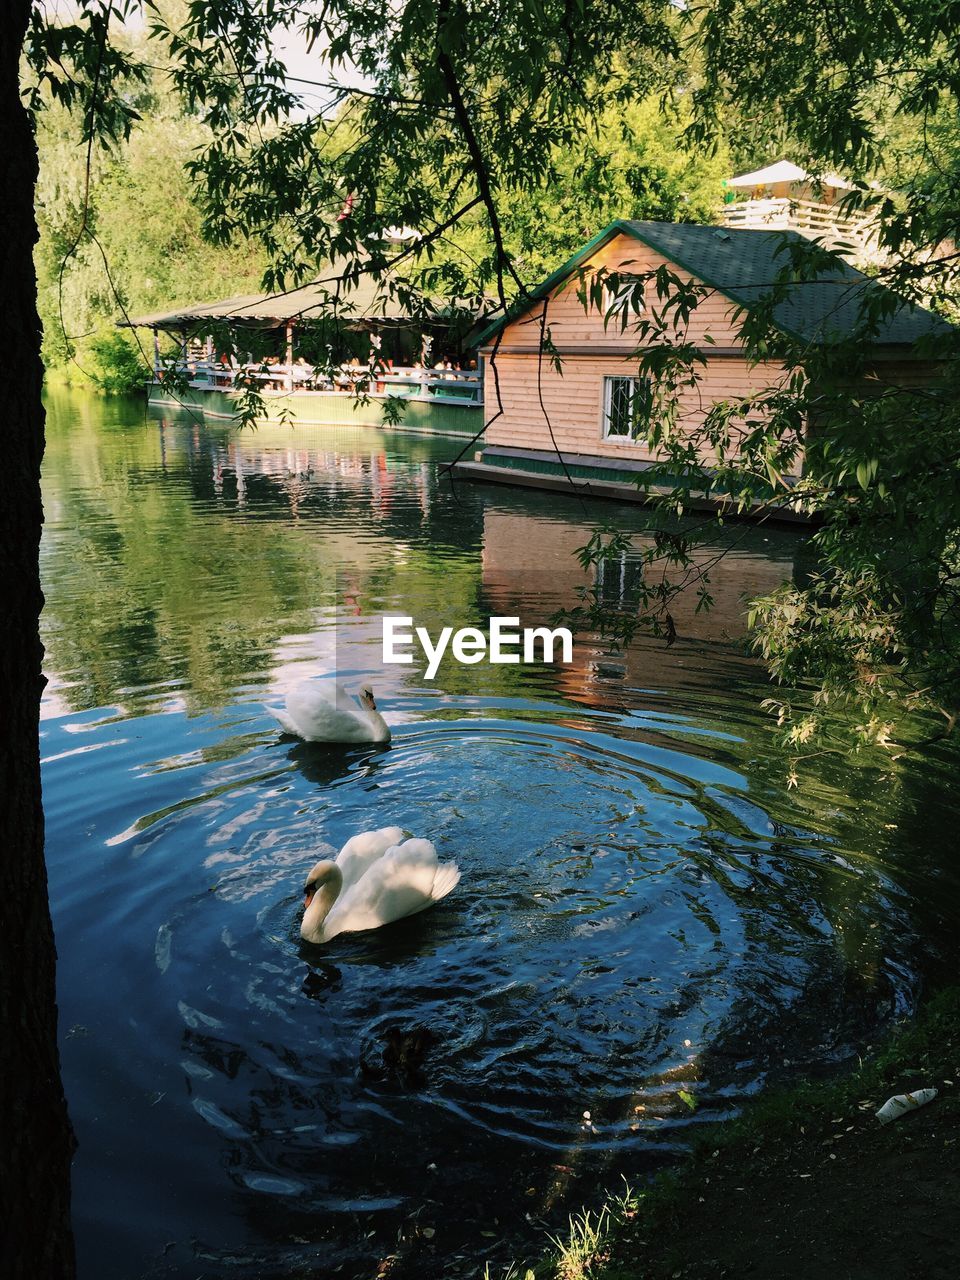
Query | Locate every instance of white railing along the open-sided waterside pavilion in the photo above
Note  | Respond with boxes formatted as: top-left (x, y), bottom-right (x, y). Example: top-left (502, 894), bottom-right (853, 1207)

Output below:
top-left (161, 360), bottom-right (484, 406)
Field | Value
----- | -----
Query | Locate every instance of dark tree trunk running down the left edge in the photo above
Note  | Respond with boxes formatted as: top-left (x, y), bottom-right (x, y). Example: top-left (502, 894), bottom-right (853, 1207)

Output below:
top-left (0, 0), bottom-right (74, 1280)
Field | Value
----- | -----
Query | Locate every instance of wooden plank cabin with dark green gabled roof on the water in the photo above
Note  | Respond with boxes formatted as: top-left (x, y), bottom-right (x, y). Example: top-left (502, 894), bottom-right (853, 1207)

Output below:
top-left (457, 221), bottom-right (948, 514)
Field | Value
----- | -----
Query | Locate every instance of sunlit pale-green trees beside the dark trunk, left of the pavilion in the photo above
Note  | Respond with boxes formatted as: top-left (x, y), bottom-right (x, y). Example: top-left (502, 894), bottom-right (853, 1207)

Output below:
top-left (37, 76), bottom-right (266, 392)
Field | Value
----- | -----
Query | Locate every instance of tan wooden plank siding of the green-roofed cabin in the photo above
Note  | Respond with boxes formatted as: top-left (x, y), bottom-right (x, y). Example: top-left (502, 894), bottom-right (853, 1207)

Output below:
top-left (484, 236), bottom-right (785, 461)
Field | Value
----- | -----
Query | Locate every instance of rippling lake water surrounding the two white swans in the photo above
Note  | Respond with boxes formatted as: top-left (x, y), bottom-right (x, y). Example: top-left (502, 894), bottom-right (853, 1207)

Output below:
top-left (42, 392), bottom-right (960, 1280)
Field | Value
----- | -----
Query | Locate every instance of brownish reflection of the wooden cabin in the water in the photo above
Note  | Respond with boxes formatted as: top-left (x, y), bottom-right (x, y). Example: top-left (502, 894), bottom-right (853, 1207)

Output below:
top-left (483, 504), bottom-right (800, 704)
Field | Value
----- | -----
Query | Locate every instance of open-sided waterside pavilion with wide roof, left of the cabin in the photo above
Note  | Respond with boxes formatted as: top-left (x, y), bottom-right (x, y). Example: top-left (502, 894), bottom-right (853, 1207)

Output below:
top-left (127, 262), bottom-right (483, 438)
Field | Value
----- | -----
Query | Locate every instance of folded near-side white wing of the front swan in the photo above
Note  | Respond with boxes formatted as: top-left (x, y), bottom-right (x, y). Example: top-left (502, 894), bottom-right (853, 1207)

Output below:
top-left (324, 840), bottom-right (460, 938)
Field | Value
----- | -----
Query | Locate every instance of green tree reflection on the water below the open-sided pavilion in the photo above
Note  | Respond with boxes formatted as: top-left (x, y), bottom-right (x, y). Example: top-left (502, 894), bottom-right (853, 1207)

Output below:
top-left (44, 394), bottom-right (476, 710)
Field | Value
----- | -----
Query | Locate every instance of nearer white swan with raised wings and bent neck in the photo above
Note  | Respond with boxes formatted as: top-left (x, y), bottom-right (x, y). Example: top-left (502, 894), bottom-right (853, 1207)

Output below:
top-left (300, 827), bottom-right (460, 942)
